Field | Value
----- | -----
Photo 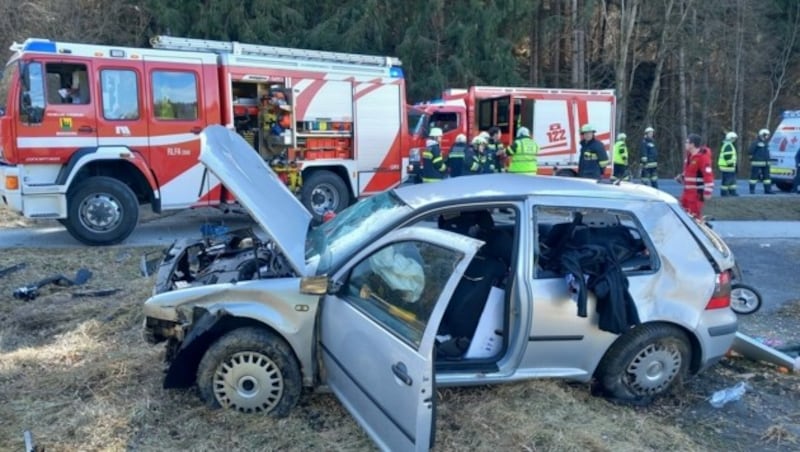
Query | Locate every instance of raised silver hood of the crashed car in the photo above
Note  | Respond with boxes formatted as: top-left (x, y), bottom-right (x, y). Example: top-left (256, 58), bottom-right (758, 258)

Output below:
top-left (200, 125), bottom-right (311, 276)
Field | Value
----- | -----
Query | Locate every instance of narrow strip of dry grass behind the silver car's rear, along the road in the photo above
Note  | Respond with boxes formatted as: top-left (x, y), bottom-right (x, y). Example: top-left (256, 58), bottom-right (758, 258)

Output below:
top-left (703, 195), bottom-right (800, 221)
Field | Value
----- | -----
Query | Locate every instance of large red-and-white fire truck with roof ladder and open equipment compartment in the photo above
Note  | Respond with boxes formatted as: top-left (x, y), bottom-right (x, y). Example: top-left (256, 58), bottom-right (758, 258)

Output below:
top-left (0, 36), bottom-right (409, 245)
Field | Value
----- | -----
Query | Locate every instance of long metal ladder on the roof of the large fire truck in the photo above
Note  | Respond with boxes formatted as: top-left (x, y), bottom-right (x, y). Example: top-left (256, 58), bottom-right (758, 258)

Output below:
top-left (150, 35), bottom-right (401, 67)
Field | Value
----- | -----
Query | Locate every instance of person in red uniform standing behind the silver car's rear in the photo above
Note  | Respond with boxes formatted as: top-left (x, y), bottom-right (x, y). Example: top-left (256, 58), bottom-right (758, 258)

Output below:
top-left (676, 133), bottom-right (714, 219)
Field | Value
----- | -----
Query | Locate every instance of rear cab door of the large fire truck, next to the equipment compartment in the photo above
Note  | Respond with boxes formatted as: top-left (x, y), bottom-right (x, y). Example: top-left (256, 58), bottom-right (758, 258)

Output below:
top-left (143, 57), bottom-right (208, 209)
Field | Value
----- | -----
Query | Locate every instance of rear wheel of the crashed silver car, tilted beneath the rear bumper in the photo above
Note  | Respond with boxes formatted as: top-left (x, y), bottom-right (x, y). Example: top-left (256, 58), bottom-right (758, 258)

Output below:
top-left (595, 324), bottom-right (691, 404)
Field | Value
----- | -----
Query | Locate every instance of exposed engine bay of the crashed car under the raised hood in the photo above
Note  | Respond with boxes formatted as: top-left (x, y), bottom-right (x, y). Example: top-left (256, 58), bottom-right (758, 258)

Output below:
top-left (155, 228), bottom-right (295, 294)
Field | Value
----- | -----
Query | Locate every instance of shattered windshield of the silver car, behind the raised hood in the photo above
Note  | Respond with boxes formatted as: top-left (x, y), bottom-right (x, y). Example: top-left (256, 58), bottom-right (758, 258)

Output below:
top-left (306, 191), bottom-right (411, 275)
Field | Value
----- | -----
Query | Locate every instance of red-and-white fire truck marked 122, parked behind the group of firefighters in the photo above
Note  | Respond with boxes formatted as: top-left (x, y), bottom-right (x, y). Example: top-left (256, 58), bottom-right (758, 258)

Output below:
top-left (409, 86), bottom-right (616, 176)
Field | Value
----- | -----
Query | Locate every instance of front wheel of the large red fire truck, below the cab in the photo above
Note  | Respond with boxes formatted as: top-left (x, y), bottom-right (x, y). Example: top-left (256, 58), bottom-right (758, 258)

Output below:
top-left (64, 176), bottom-right (139, 245)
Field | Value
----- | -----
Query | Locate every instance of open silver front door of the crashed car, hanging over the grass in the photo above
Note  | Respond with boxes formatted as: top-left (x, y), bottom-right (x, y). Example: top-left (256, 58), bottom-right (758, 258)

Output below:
top-left (320, 227), bottom-right (483, 450)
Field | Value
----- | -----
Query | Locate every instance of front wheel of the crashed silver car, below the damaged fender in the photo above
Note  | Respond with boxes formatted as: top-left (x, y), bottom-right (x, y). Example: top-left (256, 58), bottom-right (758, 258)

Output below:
top-left (197, 327), bottom-right (302, 418)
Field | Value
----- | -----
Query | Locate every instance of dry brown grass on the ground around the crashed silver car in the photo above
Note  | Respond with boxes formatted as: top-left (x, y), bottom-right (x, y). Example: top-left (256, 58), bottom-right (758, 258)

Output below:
top-left (0, 248), bottom-right (708, 451)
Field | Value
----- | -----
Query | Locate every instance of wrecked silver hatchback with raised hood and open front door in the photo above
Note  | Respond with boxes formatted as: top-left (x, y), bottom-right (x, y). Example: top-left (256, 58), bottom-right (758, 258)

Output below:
top-left (144, 126), bottom-right (737, 450)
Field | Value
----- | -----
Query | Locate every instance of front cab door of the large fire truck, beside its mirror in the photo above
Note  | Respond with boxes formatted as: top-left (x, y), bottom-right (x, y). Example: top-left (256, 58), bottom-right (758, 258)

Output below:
top-left (17, 59), bottom-right (98, 164)
